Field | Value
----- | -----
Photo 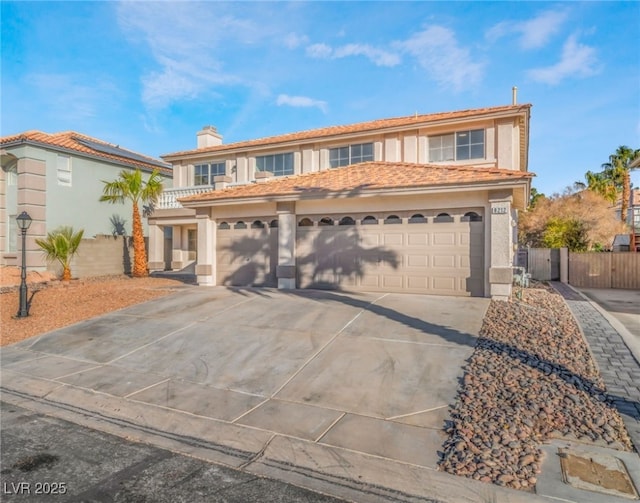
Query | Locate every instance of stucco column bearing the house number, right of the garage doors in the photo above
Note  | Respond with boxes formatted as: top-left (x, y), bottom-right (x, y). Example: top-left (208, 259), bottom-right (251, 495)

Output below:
top-left (489, 191), bottom-right (513, 300)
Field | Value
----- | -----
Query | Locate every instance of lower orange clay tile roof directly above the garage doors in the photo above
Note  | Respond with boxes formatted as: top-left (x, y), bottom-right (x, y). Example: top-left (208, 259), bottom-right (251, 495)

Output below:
top-left (180, 162), bottom-right (535, 205)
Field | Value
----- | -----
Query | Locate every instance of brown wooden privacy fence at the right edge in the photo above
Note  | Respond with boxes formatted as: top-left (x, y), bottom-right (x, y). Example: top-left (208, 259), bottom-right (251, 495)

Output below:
top-left (569, 252), bottom-right (640, 290)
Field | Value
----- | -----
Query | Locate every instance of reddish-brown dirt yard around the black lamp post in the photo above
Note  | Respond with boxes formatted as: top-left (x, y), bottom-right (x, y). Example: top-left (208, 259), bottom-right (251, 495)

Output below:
top-left (0, 267), bottom-right (184, 346)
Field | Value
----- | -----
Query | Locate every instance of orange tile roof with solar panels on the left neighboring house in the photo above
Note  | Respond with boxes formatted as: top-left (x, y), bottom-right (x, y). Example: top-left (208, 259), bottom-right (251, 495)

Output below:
top-left (0, 130), bottom-right (173, 175)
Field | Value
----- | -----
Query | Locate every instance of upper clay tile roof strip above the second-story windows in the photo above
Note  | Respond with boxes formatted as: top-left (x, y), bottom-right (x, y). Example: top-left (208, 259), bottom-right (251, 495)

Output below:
top-left (161, 104), bottom-right (531, 158)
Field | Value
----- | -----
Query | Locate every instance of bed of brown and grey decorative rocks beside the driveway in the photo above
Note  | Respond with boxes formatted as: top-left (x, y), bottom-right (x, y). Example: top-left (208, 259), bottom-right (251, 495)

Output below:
top-left (439, 287), bottom-right (632, 490)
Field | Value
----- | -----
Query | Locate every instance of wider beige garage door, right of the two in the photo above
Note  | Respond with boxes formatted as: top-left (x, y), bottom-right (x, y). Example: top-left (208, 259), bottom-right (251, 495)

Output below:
top-left (296, 209), bottom-right (484, 296)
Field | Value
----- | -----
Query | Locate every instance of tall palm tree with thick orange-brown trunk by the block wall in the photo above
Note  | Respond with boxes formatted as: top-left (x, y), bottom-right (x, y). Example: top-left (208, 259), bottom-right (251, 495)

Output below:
top-left (100, 169), bottom-right (163, 278)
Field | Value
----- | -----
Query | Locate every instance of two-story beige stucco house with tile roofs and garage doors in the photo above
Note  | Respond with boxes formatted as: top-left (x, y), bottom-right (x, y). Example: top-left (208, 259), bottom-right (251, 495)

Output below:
top-left (149, 105), bottom-right (533, 298)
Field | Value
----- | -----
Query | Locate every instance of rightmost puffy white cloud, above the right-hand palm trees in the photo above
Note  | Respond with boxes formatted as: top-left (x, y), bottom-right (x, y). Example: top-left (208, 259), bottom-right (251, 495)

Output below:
top-left (527, 35), bottom-right (600, 85)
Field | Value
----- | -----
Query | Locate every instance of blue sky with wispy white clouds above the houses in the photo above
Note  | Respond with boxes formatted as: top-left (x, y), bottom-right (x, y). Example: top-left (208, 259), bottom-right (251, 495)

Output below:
top-left (0, 0), bottom-right (640, 194)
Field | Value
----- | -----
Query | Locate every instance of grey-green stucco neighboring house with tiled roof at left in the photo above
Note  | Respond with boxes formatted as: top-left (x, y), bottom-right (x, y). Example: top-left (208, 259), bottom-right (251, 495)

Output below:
top-left (0, 131), bottom-right (172, 269)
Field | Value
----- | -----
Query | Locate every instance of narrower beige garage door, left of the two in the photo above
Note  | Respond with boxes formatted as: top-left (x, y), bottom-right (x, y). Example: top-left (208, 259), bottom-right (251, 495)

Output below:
top-left (216, 217), bottom-right (278, 287)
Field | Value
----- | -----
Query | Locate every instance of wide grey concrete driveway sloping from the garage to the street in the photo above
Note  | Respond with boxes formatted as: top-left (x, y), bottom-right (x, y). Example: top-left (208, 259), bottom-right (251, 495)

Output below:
top-left (2, 287), bottom-right (544, 501)
